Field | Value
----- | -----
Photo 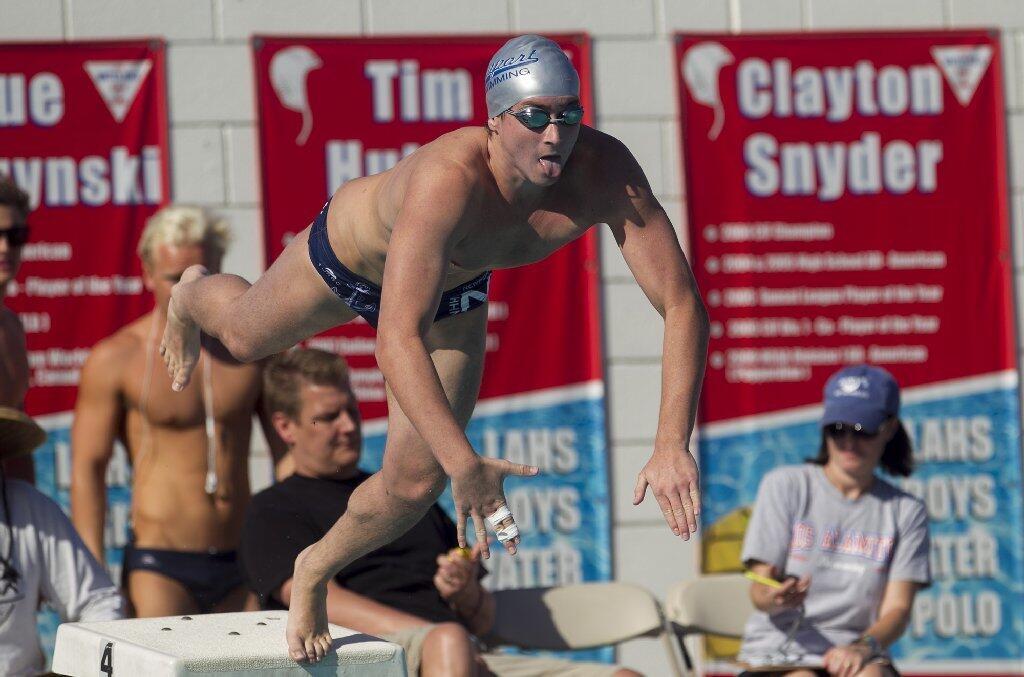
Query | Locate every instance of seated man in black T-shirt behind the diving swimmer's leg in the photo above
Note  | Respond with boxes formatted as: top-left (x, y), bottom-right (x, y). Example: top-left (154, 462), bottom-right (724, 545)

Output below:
top-left (240, 349), bottom-right (637, 677)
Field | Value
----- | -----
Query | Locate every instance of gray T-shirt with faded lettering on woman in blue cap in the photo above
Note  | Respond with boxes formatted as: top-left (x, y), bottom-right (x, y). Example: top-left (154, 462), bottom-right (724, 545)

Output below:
top-left (739, 463), bottom-right (932, 664)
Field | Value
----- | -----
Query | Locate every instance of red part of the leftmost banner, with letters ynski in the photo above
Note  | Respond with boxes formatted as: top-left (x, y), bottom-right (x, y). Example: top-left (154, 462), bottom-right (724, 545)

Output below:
top-left (0, 40), bottom-right (168, 416)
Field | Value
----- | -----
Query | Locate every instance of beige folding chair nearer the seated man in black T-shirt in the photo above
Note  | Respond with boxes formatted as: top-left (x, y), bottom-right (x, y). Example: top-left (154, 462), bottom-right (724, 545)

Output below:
top-left (486, 583), bottom-right (682, 675)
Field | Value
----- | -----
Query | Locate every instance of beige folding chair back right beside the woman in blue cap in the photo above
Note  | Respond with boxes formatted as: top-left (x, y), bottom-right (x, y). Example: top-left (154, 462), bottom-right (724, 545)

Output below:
top-left (665, 574), bottom-right (754, 674)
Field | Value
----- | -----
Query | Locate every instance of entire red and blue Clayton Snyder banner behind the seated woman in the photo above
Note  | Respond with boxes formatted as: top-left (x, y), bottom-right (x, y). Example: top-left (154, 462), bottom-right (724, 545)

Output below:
top-left (676, 31), bottom-right (1024, 675)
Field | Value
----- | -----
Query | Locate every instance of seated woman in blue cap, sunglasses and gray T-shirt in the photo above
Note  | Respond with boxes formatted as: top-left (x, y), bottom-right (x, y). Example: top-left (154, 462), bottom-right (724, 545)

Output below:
top-left (738, 365), bottom-right (931, 677)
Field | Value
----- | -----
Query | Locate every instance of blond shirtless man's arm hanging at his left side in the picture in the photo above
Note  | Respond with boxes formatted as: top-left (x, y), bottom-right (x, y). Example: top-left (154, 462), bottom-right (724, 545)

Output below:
top-left (71, 342), bottom-right (123, 563)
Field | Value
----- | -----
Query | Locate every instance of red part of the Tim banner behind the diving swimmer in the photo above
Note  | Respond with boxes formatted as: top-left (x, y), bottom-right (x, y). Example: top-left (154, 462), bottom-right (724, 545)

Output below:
top-left (254, 35), bottom-right (601, 419)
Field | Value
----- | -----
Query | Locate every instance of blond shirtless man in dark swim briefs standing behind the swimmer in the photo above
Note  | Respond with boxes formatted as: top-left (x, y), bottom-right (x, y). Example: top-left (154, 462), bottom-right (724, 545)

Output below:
top-left (71, 207), bottom-right (280, 617)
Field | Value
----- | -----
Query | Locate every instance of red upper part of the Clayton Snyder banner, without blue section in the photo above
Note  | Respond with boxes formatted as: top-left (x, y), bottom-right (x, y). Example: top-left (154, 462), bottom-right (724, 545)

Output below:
top-left (677, 31), bottom-right (1016, 422)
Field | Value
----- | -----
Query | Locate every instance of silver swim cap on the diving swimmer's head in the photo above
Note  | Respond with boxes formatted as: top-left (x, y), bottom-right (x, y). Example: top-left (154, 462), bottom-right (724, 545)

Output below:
top-left (483, 35), bottom-right (580, 118)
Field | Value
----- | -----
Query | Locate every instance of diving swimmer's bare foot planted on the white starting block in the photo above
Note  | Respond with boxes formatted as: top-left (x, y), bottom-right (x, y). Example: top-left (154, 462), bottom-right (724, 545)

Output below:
top-left (285, 545), bottom-right (331, 663)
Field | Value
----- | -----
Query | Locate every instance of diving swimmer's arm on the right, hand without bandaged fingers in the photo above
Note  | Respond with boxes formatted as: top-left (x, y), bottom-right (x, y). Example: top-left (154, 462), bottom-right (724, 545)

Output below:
top-left (601, 137), bottom-right (709, 539)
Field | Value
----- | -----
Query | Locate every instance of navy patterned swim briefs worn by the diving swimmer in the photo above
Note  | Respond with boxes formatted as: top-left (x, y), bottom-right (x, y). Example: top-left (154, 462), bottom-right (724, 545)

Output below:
top-left (309, 200), bottom-right (490, 329)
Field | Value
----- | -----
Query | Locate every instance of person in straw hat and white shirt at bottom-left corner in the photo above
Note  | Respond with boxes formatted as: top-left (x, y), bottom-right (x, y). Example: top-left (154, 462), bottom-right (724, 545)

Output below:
top-left (0, 407), bottom-right (124, 677)
